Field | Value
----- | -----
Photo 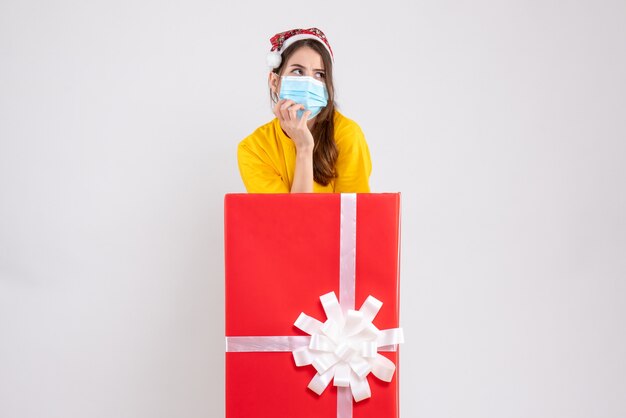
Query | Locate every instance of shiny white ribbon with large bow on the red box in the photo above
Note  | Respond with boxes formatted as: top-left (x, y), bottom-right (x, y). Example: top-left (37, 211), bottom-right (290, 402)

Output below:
top-left (226, 193), bottom-right (404, 418)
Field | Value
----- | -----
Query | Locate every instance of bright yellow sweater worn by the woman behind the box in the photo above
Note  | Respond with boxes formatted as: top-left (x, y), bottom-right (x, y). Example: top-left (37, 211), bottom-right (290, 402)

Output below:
top-left (237, 111), bottom-right (372, 193)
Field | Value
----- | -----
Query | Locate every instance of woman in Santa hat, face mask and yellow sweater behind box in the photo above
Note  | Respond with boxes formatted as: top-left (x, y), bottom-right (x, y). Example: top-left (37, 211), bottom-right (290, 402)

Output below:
top-left (237, 28), bottom-right (372, 193)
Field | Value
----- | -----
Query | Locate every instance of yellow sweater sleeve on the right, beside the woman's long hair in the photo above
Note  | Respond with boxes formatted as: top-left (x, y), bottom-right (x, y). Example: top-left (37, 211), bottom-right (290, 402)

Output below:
top-left (335, 117), bottom-right (372, 193)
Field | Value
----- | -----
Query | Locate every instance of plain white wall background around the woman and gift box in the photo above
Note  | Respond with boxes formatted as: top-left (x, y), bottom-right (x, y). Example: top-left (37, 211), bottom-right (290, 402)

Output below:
top-left (0, 0), bottom-right (626, 418)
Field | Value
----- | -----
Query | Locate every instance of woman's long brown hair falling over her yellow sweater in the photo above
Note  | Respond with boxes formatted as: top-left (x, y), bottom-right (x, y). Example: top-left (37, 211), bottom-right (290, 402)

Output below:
top-left (270, 39), bottom-right (339, 186)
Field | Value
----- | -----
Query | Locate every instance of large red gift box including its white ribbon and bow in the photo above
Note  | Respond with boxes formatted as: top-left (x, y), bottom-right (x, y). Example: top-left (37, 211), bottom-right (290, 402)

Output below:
top-left (224, 193), bottom-right (402, 418)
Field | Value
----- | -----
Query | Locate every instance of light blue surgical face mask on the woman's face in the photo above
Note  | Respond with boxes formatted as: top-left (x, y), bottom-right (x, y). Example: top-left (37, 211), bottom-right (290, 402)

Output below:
top-left (278, 76), bottom-right (328, 119)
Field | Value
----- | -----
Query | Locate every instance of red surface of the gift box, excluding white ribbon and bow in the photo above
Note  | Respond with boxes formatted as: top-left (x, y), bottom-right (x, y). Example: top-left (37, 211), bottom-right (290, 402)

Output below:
top-left (225, 193), bottom-right (400, 418)
